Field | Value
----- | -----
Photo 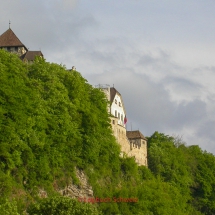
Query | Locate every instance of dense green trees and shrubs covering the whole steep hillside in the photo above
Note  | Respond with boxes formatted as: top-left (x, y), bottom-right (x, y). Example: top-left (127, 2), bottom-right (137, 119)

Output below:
top-left (0, 50), bottom-right (215, 215)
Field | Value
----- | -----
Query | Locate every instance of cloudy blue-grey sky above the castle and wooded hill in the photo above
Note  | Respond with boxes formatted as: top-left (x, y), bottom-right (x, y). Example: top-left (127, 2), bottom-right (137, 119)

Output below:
top-left (0, 0), bottom-right (215, 154)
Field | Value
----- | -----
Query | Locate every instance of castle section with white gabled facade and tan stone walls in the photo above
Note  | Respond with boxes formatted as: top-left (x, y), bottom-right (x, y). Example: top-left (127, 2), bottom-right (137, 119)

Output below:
top-left (96, 84), bottom-right (148, 166)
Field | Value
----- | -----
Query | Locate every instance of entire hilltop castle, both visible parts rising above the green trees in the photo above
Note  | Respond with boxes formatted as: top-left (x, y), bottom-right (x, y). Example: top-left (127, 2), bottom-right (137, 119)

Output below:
top-left (0, 27), bottom-right (148, 166)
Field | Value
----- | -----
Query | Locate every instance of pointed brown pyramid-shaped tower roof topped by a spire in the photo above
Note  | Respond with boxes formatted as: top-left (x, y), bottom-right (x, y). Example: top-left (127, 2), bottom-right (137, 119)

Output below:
top-left (0, 28), bottom-right (27, 47)
